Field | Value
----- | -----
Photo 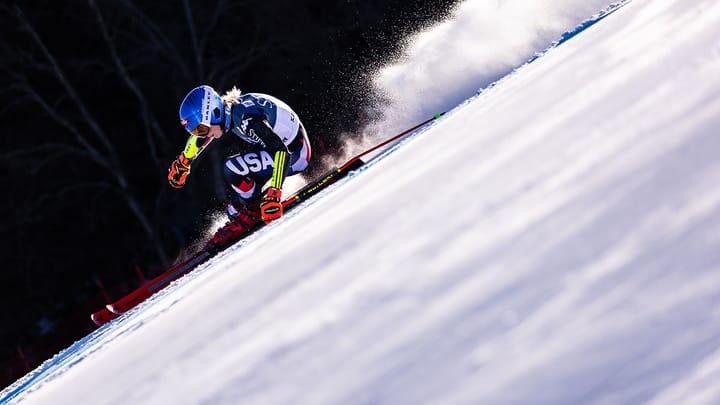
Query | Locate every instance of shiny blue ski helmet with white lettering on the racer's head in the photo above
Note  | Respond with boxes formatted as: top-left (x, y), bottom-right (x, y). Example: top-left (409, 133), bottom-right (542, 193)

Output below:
top-left (180, 86), bottom-right (224, 135)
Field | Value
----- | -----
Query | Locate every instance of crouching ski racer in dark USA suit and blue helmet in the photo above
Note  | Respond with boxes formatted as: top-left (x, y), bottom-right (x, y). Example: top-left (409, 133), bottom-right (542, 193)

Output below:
top-left (168, 85), bottom-right (311, 242)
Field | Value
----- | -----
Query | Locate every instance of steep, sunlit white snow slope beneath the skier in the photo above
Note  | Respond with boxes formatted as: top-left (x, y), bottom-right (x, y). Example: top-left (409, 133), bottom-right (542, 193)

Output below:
top-left (0, 0), bottom-right (720, 404)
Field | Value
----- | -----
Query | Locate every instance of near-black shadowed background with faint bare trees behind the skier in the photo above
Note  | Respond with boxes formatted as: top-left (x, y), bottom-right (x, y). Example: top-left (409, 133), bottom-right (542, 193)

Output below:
top-left (0, 0), bottom-right (455, 387)
